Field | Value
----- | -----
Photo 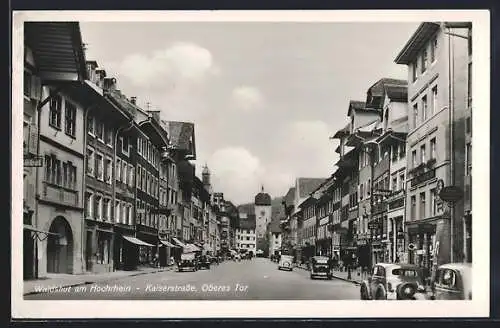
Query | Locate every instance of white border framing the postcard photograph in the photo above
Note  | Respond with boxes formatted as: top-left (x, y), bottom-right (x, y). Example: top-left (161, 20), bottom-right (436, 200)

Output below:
top-left (11, 10), bottom-right (490, 319)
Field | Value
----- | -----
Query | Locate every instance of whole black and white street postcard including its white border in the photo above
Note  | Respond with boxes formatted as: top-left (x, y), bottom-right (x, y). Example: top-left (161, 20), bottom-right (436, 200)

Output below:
top-left (11, 11), bottom-right (489, 318)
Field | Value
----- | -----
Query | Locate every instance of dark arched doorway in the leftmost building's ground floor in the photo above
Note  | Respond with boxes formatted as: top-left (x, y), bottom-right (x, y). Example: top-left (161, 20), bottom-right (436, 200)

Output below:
top-left (47, 216), bottom-right (73, 274)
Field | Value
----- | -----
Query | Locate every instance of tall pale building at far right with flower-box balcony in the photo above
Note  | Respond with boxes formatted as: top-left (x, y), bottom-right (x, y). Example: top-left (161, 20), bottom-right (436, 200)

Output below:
top-left (395, 22), bottom-right (471, 269)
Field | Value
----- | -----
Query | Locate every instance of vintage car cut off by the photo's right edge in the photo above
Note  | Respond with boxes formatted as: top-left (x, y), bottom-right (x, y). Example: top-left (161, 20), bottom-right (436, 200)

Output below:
top-left (431, 263), bottom-right (472, 300)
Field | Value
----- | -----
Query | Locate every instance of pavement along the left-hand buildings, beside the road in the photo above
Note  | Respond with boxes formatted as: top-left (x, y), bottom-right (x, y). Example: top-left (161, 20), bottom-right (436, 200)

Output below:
top-left (23, 265), bottom-right (175, 295)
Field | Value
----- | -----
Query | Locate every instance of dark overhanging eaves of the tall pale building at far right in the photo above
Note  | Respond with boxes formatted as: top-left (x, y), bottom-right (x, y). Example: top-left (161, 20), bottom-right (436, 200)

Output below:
top-left (394, 22), bottom-right (440, 65)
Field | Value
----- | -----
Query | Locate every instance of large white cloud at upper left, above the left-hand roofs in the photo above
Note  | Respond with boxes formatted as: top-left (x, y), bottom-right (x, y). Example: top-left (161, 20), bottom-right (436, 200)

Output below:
top-left (118, 42), bottom-right (216, 89)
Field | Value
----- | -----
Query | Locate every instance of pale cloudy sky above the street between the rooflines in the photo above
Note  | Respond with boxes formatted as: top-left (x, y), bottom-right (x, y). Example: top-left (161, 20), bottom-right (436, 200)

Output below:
top-left (80, 22), bottom-right (418, 204)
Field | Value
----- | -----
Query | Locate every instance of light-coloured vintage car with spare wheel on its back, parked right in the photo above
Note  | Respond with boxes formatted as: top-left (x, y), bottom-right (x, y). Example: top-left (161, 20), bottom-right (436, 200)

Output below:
top-left (360, 263), bottom-right (425, 300)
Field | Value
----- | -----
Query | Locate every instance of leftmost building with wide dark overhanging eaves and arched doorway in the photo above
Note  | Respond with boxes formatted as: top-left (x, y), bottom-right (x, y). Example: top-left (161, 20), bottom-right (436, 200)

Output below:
top-left (23, 23), bottom-right (87, 278)
